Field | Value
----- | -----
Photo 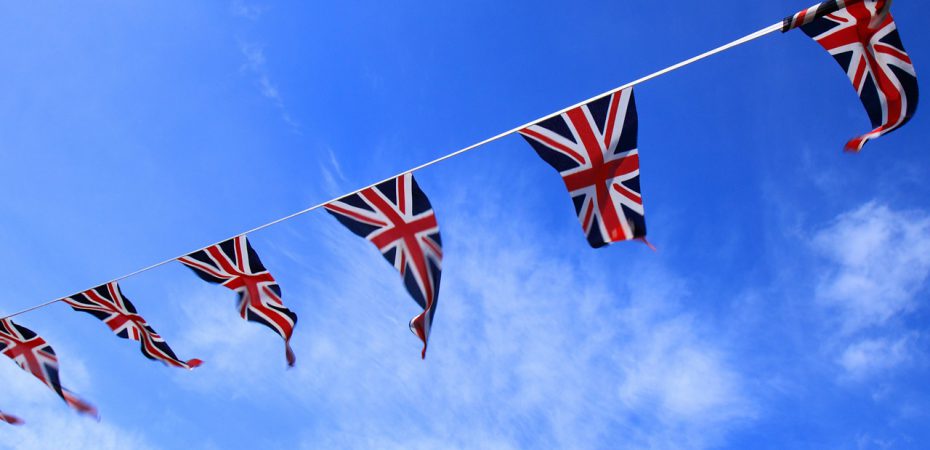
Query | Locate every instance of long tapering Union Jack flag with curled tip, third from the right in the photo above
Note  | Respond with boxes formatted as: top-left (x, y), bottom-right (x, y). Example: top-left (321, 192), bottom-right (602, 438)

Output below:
top-left (326, 173), bottom-right (442, 358)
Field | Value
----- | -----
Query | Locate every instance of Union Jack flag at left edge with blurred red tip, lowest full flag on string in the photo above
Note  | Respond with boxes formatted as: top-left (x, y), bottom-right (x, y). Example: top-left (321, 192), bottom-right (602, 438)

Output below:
top-left (0, 319), bottom-right (97, 417)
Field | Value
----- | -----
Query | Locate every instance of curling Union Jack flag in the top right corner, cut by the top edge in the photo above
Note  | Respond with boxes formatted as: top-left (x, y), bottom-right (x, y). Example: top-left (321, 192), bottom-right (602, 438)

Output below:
top-left (786, 0), bottom-right (918, 152)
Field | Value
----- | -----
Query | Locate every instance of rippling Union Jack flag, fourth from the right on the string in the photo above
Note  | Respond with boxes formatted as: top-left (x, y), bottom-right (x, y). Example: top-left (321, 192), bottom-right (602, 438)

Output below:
top-left (178, 236), bottom-right (297, 366)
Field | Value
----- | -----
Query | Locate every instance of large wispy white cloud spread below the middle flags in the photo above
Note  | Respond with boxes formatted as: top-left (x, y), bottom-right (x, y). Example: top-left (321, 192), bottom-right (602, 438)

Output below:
top-left (170, 213), bottom-right (754, 449)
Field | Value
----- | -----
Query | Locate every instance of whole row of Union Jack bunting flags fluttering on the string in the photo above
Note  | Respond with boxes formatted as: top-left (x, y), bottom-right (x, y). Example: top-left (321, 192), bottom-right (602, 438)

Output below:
top-left (0, 0), bottom-right (918, 424)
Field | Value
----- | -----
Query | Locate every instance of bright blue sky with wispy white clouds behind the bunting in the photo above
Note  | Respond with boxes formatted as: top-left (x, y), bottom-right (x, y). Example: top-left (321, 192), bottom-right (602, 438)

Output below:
top-left (0, 0), bottom-right (930, 449)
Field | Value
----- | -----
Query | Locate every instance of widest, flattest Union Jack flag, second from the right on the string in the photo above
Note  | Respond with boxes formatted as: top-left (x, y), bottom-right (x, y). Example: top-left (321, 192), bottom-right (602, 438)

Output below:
top-left (520, 88), bottom-right (646, 248)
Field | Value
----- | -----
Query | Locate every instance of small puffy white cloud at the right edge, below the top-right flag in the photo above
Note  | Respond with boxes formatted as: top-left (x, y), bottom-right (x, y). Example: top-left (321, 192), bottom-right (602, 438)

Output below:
top-left (813, 202), bottom-right (930, 379)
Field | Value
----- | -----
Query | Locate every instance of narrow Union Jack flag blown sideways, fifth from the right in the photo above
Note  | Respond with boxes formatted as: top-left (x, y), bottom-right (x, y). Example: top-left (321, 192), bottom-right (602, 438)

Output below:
top-left (64, 282), bottom-right (202, 369)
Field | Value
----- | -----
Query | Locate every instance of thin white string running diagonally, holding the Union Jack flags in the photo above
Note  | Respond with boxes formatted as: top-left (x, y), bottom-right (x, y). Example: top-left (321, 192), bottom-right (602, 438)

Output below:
top-left (0, 22), bottom-right (783, 320)
